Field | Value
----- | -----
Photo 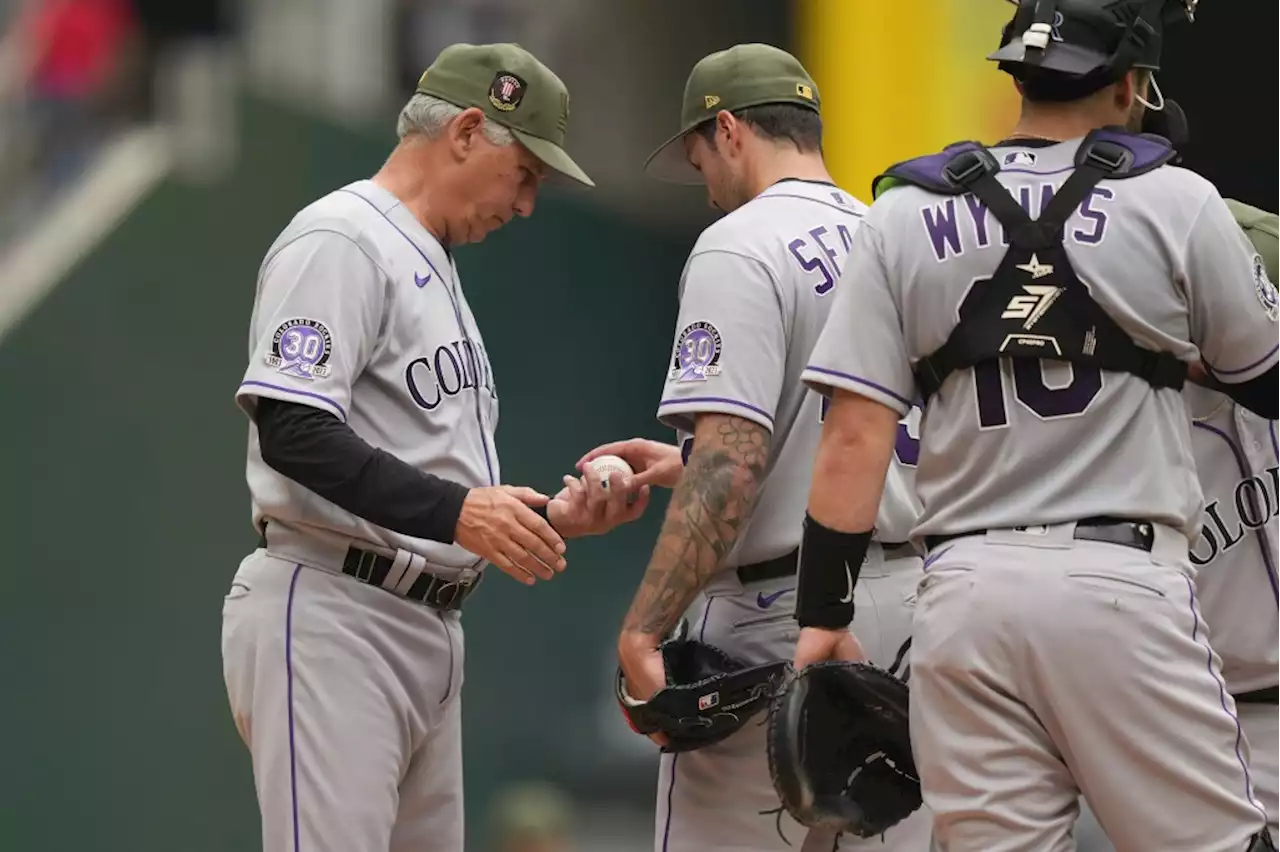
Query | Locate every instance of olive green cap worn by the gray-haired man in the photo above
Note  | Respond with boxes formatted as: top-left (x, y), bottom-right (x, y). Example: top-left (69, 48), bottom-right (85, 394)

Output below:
top-left (417, 43), bottom-right (595, 187)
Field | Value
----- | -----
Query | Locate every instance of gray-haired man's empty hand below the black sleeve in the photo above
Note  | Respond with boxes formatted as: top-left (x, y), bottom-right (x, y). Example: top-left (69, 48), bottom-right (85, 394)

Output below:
top-left (453, 485), bottom-right (564, 586)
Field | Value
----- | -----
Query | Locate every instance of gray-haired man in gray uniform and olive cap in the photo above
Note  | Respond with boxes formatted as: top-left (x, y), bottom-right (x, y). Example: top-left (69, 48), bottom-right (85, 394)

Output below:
top-left (223, 45), bottom-right (599, 852)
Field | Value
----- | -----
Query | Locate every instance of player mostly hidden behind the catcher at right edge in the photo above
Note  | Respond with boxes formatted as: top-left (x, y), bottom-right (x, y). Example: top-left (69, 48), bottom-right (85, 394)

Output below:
top-left (1080, 200), bottom-right (1280, 852)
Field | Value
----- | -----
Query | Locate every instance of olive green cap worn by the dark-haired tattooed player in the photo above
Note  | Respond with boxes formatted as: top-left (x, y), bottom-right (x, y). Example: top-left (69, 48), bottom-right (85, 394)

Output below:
top-left (645, 43), bottom-right (819, 183)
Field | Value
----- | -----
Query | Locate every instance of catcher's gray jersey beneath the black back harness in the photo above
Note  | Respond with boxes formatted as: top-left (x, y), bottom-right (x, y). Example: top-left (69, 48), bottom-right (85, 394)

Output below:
top-left (804, 141), bottom-right (1280, 537)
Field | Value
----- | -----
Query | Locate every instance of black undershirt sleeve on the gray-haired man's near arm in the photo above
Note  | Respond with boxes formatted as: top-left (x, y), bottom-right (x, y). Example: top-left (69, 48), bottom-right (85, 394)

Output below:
top-left (255, 397), bottom-right (470, 544)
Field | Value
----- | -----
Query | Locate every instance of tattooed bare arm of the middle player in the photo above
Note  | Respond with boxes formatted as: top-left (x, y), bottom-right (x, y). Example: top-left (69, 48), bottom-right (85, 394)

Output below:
top-left (623, 414), bottom-right (771, 636)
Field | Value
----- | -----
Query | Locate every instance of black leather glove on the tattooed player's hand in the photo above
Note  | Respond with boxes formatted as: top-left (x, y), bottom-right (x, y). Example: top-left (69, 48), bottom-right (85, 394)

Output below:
top-left (616, 631), bottom-right (788, 752)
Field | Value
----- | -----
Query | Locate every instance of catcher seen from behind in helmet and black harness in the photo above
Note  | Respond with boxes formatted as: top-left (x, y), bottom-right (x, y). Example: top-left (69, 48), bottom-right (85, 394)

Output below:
top-left (795, 0), bottom-right (1280, 852)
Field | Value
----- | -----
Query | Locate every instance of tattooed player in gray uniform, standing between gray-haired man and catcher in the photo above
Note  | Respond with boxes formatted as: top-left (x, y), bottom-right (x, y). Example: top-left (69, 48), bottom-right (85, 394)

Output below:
top-left (558, 45), bottom-right (929, 852)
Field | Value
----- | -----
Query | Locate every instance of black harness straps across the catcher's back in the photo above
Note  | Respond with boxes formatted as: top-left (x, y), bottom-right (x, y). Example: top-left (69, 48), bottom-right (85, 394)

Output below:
top-left (872, 128), bottom-right (1187, 402)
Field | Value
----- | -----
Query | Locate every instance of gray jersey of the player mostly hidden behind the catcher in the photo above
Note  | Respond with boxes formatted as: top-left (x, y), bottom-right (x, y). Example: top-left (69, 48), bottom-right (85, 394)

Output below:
top-left (1184, 385), bottom-right (1280, 695)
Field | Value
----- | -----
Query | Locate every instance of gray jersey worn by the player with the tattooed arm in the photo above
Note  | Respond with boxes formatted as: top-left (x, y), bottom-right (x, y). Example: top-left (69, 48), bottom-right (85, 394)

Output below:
top-left (658, 179), bottom-right (918, 567)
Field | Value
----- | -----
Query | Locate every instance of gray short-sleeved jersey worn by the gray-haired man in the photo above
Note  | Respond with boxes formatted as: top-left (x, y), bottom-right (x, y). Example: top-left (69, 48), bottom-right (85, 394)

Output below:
top-left (237, 180), bottom-right (499, 573)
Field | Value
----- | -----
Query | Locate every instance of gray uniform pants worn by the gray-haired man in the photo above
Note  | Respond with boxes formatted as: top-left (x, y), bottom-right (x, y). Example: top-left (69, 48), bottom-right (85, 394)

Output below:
top-left (223, 550), bottom-right (462, 852)
